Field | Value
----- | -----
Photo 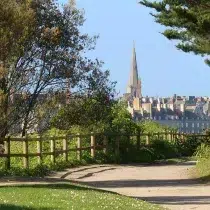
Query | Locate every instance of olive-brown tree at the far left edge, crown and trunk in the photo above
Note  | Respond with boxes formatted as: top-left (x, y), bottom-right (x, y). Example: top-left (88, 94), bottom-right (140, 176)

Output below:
top-left (0, 0), bottom-right (34, 137)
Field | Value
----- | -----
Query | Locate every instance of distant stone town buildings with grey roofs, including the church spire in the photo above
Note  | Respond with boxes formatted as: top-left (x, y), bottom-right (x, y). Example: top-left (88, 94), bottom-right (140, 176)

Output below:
top-left (123, 45), bottom-right (210, 133)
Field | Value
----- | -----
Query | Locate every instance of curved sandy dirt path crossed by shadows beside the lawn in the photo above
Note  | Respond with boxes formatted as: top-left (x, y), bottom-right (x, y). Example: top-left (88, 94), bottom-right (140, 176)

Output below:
top-left (55, 162), bottom-right (210, 210)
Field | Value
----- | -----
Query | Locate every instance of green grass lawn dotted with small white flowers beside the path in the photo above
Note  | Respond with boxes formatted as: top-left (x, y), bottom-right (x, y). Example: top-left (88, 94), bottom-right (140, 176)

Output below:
top-left (0, 183), bottom-right (164, 210)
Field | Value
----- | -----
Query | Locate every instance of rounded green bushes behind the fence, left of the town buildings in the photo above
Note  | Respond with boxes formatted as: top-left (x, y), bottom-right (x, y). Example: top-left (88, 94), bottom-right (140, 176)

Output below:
top-left (52, 100), bottom-right (140, 133)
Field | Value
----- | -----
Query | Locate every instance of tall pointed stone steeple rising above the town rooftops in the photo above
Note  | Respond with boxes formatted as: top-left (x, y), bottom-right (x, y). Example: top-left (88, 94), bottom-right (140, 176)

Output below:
top-left (127, 42), bottom-right (141, 98)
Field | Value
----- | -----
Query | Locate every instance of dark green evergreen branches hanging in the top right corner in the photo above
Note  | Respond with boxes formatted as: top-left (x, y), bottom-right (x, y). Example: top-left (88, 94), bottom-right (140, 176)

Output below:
top-left (140, 0), bottom-right (210, 66)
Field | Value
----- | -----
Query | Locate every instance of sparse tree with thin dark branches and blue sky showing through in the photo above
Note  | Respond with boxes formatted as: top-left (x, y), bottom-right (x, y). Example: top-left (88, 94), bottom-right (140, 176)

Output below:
top-left (19, 1), bottom-right (96, 136)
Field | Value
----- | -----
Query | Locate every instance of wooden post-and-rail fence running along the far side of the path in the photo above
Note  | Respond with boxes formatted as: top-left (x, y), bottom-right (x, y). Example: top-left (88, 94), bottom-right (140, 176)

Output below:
top-left (0, 132), bottom-right (210, 169)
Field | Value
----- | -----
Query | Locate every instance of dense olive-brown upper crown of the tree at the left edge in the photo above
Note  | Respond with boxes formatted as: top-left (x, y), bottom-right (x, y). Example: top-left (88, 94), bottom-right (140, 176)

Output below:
top-left (0, 0), bottom-right (35, 62)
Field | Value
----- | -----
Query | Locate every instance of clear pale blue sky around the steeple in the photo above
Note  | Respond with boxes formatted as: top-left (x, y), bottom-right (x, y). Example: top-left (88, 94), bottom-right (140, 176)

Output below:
top-left (60, 0), bottom-right (210, 96)
